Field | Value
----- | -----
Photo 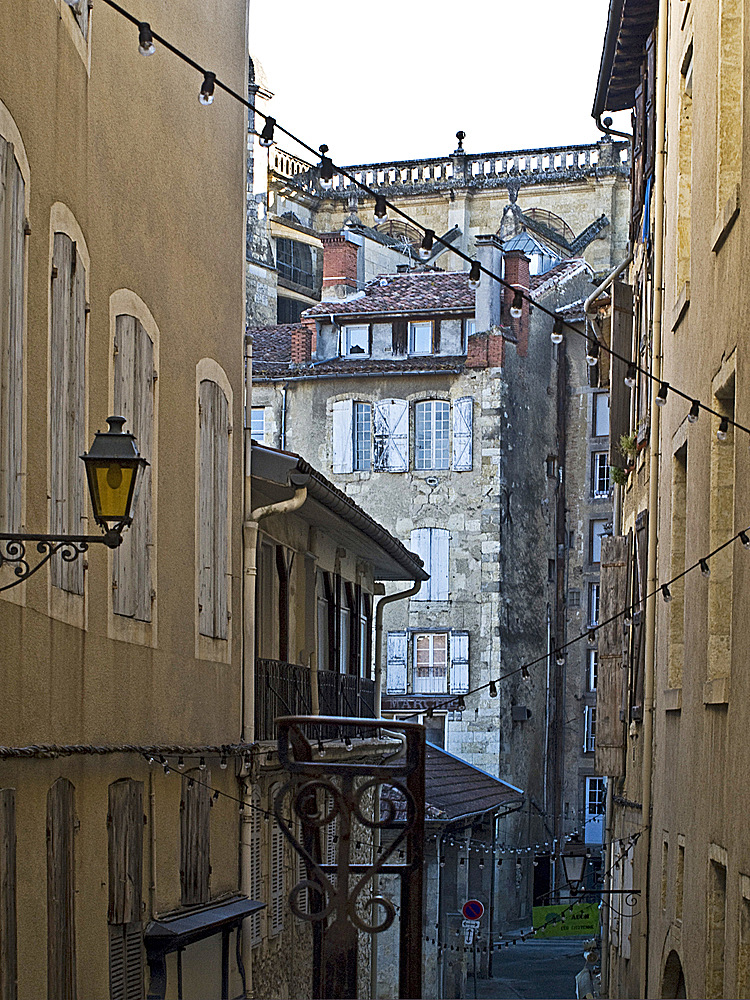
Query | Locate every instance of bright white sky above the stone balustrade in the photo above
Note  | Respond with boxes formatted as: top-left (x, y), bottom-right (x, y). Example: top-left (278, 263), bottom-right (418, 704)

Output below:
top-left (249, 0), bottom-right (629, 165)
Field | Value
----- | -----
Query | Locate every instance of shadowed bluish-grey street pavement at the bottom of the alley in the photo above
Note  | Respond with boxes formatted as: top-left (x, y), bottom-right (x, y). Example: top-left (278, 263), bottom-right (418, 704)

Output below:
top-left (466, 938), bottom-right (585, 1000)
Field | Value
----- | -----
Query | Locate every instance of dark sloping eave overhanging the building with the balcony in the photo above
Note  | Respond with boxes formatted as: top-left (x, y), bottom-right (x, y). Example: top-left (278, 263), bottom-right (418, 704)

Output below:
top-left (250, 442), bottom-right (430, 581)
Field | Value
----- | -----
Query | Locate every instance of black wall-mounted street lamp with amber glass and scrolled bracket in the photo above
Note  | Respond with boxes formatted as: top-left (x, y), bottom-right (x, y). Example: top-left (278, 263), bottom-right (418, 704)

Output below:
top-left (0, 417), bottom-right (148, 592)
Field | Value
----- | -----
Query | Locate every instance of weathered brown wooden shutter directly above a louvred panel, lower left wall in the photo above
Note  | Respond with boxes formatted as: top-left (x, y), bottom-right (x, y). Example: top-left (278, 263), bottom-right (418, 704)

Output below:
top-left (107, 778), bottom-right (143, 924)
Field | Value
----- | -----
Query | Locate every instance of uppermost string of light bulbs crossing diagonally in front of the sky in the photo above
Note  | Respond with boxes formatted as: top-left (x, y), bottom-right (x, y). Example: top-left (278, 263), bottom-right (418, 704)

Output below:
top-left (92, 0), bottom-right (750, 440)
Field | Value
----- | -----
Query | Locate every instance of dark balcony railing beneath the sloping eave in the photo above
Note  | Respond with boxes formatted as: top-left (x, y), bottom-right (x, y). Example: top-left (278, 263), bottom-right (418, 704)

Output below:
top-left (255, 659), bottom-right (375, 740)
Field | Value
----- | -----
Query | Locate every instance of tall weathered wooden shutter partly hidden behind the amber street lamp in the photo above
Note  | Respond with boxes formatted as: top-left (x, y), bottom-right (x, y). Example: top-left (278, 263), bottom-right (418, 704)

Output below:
top-left (113, 316), bottom-right (154, 622)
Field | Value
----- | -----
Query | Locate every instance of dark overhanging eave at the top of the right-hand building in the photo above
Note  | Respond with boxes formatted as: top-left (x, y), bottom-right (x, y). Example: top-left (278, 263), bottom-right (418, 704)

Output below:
top-left (591, 0), bottom-right (659, 118)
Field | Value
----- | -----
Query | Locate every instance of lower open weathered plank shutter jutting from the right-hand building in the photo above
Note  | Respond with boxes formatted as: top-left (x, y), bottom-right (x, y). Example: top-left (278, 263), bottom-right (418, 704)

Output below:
top-left (594, 536), bottom-right (628, 777)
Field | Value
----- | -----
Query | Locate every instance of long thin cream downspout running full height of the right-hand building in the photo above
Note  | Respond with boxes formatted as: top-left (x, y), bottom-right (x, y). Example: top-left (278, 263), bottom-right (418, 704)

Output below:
top-left (641, 3), bottom-right (668, 997)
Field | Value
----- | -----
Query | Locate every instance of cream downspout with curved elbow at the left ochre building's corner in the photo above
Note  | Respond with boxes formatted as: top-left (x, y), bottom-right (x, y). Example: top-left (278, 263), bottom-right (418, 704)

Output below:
top-left (240, 400), bottom-right (307, 997)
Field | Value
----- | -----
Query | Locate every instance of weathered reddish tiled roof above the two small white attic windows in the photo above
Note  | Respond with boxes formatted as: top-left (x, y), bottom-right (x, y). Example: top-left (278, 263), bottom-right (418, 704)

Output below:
top-left (305, 271), bottom-right (474, 316)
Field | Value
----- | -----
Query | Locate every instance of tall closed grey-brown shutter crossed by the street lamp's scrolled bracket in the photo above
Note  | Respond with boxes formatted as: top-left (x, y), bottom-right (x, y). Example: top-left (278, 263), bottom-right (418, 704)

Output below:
top-left (50, 233), bottom-right (86, 594)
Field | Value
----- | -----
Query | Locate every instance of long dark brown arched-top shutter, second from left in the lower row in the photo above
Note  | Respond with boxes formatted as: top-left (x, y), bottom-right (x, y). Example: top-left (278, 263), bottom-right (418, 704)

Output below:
top-left (47, 778), bottom-right (77, 1000)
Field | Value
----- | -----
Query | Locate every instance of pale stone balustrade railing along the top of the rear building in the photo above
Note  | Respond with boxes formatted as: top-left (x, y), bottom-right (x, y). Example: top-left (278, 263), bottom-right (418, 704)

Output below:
top-left (278, 139), bottom-right (630, 197)
